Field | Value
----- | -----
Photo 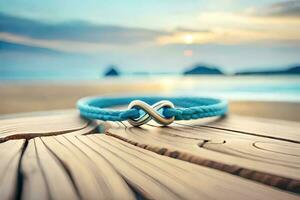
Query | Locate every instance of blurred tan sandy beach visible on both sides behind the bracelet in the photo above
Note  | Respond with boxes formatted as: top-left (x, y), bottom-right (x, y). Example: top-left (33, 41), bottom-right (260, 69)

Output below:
top-left (0, 82), bottom-right (300, 121)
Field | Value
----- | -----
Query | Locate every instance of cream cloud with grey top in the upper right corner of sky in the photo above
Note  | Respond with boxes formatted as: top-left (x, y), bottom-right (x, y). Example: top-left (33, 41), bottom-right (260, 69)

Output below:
top-left (198, 0), bottom-right (300, 30)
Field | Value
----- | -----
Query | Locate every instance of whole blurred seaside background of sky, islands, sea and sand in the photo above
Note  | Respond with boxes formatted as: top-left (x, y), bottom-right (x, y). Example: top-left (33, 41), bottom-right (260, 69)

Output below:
top-left (0, 0), bottom-right (300, 120)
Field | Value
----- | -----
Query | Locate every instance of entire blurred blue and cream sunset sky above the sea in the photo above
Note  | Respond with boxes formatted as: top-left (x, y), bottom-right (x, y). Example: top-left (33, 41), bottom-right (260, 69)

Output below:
top-left (0, 0), bottom-right (300, 76)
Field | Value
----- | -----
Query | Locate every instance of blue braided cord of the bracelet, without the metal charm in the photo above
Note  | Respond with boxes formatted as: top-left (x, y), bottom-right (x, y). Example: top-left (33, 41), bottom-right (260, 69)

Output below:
top-left (77, 97), bottom-right (228, 121)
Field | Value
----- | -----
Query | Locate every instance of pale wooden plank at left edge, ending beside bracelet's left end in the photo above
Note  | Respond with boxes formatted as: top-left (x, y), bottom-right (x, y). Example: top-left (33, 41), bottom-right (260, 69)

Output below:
top-left (0, 112), bottom-right (99, 142)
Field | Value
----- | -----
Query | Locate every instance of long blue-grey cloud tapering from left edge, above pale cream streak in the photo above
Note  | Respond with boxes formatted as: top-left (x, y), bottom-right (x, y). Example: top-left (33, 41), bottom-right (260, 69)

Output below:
top-left (0, 13), bottom-right (167, 45)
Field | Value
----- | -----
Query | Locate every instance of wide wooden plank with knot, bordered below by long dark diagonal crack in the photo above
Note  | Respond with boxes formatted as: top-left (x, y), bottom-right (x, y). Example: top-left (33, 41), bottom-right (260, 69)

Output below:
top-left (107, 119), bottom-right (300, 192)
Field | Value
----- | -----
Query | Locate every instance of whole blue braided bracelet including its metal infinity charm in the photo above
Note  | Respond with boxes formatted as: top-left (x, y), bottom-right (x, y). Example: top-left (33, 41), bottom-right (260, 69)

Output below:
top-left (77, 97), bottom-right (228, 126)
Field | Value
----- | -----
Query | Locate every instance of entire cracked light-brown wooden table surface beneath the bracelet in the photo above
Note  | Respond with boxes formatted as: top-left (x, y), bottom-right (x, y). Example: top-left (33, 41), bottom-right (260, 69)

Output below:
top-left (0, 111), bottom-right (300, 200)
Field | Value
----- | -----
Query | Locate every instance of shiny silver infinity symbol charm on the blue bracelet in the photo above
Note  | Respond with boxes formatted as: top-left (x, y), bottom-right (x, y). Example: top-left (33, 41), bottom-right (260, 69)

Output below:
top-left (128, 100), bottom-right (175, 126)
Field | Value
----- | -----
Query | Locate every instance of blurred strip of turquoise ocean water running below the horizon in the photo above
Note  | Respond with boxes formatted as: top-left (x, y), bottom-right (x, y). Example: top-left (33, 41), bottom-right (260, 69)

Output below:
top-left (0, 71), bottom-right (300, 102)
